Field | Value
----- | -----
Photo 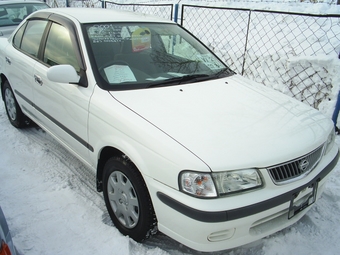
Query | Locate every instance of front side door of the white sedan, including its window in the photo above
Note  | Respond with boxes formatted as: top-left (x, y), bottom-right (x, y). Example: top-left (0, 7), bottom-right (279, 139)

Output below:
top-left (34, 19), bottom-right (92, 163)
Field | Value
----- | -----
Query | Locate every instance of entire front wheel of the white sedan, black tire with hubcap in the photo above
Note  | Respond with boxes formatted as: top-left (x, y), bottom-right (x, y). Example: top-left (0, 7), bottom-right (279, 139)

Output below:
top-left (103, 157), bottom-right (157, 242)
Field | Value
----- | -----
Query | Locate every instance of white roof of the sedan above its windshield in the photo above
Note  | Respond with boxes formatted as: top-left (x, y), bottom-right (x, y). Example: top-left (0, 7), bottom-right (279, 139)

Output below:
top-left (33, 8), bottom-right (174, 24)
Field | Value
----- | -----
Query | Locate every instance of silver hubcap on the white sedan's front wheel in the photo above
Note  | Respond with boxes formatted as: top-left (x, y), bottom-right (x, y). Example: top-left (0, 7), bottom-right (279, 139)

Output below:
top-left (107, 171), bottom-right (139, 229)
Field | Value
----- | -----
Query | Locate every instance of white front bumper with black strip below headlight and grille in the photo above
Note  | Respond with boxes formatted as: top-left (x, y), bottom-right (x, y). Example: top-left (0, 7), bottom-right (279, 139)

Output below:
top-left (149, 148), bottom-right (339, 252)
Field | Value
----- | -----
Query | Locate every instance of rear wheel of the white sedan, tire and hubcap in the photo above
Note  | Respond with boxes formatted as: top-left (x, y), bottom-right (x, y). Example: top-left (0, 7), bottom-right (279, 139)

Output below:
top-left (3, 81), bottom-right (29, 128)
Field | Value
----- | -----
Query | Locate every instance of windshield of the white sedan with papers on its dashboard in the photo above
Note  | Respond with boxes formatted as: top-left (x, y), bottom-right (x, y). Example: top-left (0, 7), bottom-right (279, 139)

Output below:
top-left (85, 23), bottom-right (234, 90)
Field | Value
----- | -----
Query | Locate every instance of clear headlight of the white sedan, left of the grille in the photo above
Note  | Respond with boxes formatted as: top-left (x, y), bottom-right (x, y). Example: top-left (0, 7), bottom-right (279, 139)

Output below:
top-left (179, 169), bottom-right (262, 198)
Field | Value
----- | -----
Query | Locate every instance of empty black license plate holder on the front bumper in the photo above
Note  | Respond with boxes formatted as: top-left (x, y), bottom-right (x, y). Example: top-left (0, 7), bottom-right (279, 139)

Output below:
top-left (288, 182), bottom-right (318, 219)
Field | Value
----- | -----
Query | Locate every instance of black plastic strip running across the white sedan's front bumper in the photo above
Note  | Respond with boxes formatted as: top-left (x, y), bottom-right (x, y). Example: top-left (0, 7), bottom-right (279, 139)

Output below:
top-left (157, 151), bottom-right (339, 223)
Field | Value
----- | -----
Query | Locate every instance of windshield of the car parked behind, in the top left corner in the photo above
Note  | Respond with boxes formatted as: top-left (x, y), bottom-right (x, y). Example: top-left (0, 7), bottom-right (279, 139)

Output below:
top-left (0, 2), bottom-right (48, 27)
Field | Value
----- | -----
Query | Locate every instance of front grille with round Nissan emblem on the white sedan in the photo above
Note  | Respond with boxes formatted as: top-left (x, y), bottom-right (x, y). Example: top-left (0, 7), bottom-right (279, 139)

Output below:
top-left (268, 146), bottom-right (324, 184)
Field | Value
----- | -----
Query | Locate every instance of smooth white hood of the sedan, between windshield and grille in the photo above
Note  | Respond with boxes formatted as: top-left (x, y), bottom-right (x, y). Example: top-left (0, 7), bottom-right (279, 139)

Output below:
top-left (111, 75), bottom-right (332, 171)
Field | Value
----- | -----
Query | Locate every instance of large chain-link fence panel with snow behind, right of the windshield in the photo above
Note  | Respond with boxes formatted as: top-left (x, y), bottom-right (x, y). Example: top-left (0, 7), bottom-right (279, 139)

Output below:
top-left (181, 5), bottom-right (340, 108)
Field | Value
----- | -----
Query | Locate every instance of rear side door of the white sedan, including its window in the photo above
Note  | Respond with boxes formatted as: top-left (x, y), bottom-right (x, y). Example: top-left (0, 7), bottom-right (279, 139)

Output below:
top-left (4, 20), bottom-right (48, 117)
